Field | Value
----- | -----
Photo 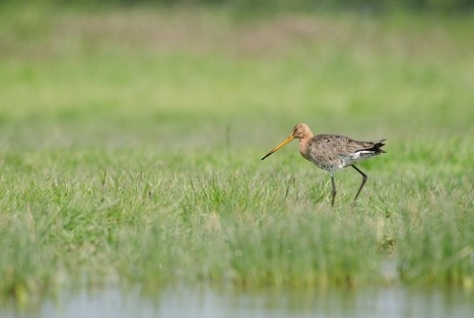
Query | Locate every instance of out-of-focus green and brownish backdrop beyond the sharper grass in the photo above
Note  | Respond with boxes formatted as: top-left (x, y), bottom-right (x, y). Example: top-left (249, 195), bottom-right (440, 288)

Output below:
top-left (0, 1), bottom-right (473, 146)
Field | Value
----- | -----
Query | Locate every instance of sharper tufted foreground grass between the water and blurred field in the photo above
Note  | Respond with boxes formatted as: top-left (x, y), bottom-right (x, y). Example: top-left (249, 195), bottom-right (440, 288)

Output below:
top-left (1, 143), bottom-right (474, 302)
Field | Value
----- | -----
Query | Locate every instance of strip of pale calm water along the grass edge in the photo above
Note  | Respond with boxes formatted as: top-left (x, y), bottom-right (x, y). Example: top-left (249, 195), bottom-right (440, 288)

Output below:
top-left (0, 286), bottom-right (474, 317)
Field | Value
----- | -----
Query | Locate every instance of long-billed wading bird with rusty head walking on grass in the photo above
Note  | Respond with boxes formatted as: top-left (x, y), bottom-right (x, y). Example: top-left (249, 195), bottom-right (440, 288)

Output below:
top-left (261, 123), bottom-right (386, 207)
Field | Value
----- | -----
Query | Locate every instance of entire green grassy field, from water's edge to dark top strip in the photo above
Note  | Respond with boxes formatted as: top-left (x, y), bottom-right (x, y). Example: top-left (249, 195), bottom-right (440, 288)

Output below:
top-left (0, 1), bottom-right (474, 304)
